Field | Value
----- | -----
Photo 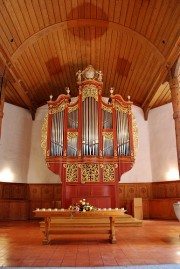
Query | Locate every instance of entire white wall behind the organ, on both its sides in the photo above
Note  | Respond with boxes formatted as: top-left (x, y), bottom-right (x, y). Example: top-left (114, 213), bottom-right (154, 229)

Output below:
top-left (0, 103), bottom-right (179, 183)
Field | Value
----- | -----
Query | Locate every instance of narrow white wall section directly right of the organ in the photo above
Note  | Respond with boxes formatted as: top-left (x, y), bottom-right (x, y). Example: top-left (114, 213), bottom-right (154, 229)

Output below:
top-left (120, 106), bottom-right (152, 183)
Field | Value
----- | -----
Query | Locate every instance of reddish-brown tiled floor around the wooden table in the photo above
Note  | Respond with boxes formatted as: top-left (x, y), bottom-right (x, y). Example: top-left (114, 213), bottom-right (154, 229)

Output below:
top-left (0, 220), bottom-right (180, 267)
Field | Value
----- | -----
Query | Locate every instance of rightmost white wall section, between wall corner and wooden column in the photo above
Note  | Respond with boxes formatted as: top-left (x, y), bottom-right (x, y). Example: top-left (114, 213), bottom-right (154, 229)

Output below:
top-left (148, 104), bottom-right (179, 181)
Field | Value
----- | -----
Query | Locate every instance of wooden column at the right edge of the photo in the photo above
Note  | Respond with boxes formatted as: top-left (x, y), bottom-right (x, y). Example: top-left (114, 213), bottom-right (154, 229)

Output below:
top-left (169, 65), bottom-right (180, 174)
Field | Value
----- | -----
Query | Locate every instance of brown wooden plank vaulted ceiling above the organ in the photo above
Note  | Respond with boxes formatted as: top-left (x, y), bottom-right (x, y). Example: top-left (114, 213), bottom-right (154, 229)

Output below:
top-left (0, 0), bottom-right (180, 119)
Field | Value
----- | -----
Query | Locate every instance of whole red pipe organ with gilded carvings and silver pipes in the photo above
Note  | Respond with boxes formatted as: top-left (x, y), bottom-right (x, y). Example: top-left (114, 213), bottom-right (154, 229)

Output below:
top-left (42, 65), bottom-right (137, 208)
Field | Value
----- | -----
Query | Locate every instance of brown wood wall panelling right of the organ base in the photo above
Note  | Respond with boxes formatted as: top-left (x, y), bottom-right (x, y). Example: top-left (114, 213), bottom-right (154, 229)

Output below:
top-left (119, 180), bottom-right (180, 219)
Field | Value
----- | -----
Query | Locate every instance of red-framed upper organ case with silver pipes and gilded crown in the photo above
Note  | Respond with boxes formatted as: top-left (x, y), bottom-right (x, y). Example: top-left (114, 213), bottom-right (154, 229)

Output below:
top-left (43, 66), bottom-right (134, 178)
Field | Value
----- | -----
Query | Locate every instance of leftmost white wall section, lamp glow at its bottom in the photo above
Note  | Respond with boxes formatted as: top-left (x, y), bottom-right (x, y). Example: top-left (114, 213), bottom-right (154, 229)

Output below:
top-left (0, 103), bottom-right (32, 183)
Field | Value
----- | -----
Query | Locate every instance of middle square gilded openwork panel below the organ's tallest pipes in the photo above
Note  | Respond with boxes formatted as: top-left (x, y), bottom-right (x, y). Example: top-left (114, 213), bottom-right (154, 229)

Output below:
top-left (81, 164), bottom-right (99, 183)
